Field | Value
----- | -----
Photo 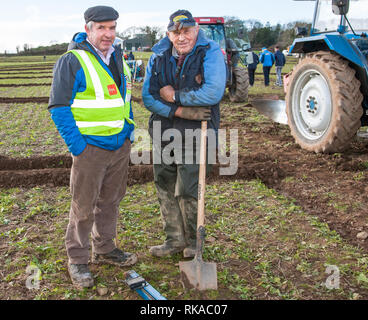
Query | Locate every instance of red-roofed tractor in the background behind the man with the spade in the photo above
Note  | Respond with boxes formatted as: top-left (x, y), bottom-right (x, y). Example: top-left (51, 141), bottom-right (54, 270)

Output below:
top-left (194, 17), bottom-right (252, 102)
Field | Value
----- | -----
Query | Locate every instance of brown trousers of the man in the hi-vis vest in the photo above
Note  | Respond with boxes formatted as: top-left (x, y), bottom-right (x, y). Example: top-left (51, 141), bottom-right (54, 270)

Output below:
top-left (65, 139), bottom-right (131, 264)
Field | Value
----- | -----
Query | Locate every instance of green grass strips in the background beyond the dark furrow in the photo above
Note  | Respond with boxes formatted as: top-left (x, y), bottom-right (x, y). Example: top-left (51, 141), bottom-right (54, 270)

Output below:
top-left (0, 52), bottom-right (291, 157)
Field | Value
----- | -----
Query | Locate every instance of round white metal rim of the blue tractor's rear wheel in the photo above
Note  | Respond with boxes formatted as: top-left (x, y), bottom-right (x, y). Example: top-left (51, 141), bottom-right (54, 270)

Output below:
top-left (292, 70), bottom-right (332, 140)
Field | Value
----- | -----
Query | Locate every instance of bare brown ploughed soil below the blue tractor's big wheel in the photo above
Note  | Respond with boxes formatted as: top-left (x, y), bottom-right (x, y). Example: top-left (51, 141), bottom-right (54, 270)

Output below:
top-left (223, 105), bottom-right (368, 254)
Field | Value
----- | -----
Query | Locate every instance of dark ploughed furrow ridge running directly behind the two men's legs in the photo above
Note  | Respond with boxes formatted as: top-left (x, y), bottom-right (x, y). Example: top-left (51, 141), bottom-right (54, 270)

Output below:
top-left (0, 155), bottom-right (285, 188)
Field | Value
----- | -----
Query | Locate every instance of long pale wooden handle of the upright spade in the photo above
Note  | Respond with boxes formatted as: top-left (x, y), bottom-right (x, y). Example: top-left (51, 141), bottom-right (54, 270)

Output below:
top-left (197, 121), bottom-right (207, 229)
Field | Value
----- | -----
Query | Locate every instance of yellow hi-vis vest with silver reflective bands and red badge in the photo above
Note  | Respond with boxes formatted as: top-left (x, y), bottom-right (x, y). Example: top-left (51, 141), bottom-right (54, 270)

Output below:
top-left (69, 50), bottom-right (134, 136)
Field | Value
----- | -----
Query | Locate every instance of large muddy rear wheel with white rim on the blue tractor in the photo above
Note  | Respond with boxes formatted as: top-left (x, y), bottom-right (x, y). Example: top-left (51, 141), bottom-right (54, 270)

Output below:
top-left (286, 51), bottom-right (363, 153)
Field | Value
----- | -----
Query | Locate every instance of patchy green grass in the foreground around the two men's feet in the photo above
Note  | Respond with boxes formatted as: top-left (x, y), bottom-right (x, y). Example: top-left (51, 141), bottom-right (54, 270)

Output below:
top-left (0, 180), bottom-right (368, 300)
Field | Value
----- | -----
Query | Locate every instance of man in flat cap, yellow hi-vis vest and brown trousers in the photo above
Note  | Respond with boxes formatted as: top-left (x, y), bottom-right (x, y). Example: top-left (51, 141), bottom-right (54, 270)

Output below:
top-left (49, 6), bottom-right (137, 288)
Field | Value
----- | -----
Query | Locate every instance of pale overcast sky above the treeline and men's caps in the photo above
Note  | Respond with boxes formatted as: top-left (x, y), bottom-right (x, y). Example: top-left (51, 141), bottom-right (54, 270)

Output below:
top-left (0, 0), bottom-right (314, 53)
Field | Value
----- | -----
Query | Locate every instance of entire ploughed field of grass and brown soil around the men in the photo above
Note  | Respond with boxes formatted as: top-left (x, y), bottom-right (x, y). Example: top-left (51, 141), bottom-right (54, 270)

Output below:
top-left (0, 53), bottom-right (368, 300)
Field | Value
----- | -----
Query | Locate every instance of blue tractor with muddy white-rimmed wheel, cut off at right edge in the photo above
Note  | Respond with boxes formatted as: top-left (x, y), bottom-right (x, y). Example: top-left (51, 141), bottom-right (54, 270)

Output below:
top-left (286, 0), bottom-right (368, 153)
